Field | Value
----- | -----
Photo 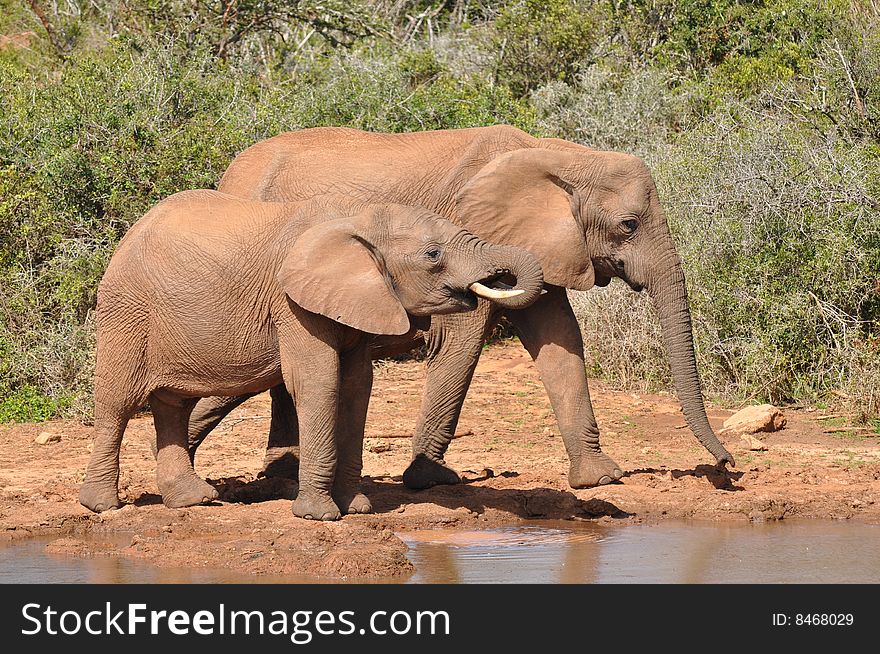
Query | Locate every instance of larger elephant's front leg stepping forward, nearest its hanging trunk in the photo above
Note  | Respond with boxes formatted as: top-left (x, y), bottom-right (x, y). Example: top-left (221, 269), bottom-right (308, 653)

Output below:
top-left (507, 286), bottom-right (623, 488)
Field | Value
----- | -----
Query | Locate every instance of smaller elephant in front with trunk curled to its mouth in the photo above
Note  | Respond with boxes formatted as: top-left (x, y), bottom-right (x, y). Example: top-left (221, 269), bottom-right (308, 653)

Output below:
top-left (79, 190), bottom-right (543, 520)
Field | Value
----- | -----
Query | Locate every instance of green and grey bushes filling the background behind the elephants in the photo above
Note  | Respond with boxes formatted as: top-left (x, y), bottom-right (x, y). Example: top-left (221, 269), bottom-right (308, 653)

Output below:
top-left (0, 0), bottom-right (880, 422)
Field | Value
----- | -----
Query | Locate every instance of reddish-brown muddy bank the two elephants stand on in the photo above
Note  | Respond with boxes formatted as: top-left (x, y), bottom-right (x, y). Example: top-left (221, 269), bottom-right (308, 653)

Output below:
top-left (0, 341), bottom-right (880, 580)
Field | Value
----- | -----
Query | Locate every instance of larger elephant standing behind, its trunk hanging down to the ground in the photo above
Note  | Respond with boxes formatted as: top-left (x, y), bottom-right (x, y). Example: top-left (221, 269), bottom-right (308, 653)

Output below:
top-left (189, 126), bottom-right (734, 488)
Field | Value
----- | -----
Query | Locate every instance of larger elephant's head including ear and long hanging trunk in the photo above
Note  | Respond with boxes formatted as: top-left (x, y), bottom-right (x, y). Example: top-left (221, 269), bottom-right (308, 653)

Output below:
top-left (456, 149), bottom-right (734, 465)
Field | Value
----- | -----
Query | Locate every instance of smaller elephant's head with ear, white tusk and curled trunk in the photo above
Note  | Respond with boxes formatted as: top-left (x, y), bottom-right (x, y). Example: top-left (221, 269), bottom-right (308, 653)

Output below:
top-left (278, 204), bottom-right (543, 335)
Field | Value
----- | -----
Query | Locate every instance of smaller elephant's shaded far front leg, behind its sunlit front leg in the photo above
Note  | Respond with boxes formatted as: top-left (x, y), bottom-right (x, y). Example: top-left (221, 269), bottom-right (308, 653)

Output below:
top-left (333, 344), bottom-right (373, 513)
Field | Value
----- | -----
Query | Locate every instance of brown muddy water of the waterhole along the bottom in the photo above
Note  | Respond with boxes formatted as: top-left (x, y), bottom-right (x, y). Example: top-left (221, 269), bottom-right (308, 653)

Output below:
top-left (0, 521), bottom-right (880, 584)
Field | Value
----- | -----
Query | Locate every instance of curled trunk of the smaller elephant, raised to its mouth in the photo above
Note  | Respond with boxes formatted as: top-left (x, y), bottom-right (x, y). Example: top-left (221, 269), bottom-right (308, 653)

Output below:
top-left (469, 245), bottom-right (544, 309)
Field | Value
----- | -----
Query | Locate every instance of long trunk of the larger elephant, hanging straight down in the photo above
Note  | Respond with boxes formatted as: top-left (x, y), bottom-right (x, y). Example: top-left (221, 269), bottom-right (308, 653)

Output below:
top-left (648, 250), bottom-right (736, 466)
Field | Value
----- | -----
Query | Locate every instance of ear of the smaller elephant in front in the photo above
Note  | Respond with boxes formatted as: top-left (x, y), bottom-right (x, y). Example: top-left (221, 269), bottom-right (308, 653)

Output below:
top-left (277, 219), bottom-right (410, 335)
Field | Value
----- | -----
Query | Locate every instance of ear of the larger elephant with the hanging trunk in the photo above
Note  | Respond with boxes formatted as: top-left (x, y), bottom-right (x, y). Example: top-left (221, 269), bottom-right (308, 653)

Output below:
top-left (456, 148), bottom-right (595, 290)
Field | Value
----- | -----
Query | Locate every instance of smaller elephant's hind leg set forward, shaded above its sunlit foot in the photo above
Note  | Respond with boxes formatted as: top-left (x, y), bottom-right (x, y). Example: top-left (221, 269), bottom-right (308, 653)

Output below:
top-left (150, 392), bottom-right (218, 509)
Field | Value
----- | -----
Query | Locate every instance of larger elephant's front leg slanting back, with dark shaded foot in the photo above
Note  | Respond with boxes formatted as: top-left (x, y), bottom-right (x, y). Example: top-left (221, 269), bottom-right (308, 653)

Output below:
top-left (403, 300), bottom-right (498, 490)
